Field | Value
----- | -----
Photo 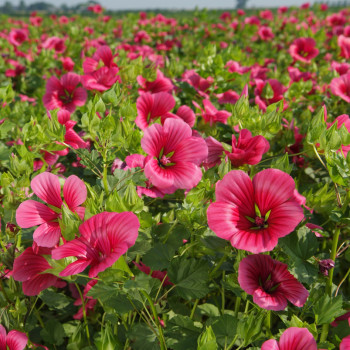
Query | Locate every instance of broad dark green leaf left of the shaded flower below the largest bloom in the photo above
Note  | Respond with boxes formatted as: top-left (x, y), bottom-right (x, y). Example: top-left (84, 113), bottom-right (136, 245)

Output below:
top-left (168, 256), bottom-right (209, 300)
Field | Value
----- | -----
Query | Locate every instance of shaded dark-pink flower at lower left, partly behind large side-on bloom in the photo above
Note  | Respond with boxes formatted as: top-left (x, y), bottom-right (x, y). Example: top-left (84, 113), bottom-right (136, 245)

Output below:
top-left (12, 247), bottom-right (65, 296)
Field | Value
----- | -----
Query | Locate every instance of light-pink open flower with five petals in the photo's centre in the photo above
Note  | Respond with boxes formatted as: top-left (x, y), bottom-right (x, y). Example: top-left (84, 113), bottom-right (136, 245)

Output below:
top-left (141, 118), bottom-right (208, 190)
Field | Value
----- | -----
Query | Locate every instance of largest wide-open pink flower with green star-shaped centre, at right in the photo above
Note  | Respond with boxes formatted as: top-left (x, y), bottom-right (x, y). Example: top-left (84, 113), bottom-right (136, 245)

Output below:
top-left (207, 169), bottom-right (304, 253)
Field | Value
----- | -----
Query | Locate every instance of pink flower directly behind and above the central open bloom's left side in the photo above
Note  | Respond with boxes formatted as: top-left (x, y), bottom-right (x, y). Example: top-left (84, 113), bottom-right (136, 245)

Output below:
top-left (135, 92), bottom-right (175, 130)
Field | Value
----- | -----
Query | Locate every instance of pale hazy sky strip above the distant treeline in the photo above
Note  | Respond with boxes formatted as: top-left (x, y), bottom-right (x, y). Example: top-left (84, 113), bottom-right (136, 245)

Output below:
top-left (0, 0), bottom-right (338, 10)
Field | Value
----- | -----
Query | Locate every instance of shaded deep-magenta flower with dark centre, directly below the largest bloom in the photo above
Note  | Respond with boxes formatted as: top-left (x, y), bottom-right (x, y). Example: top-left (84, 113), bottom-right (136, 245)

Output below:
top-left (238, 254), bottom-right (309, 311)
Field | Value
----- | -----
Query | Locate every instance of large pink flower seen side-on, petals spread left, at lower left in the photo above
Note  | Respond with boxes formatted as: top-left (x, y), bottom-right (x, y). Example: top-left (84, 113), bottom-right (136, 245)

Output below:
top-left (52, 212), bottom-right (140, 278)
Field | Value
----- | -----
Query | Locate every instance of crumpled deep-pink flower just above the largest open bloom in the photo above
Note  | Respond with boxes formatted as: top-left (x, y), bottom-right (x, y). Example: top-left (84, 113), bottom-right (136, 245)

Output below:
top-left (225, 129), bottom-right (270, 167)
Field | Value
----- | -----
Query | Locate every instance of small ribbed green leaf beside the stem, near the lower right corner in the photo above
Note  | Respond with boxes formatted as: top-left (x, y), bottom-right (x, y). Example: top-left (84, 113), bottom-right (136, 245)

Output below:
top-left (313, 294), bottom-right (345, 325)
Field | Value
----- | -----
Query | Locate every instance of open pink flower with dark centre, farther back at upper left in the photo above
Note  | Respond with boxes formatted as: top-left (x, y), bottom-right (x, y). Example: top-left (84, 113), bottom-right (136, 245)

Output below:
top-left (43, 73), bottom-right (87, 113)
